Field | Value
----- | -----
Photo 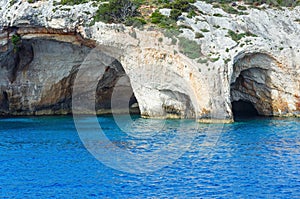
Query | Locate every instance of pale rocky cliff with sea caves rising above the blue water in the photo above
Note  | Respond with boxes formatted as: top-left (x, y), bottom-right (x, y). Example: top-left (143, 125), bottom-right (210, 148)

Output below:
top-left (0, 0), bottom-right (300, 122)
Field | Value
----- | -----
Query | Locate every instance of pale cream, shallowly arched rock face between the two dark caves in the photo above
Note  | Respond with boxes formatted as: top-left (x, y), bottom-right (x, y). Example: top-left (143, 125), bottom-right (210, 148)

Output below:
top-left (118, 46), bottom-right (198, 119)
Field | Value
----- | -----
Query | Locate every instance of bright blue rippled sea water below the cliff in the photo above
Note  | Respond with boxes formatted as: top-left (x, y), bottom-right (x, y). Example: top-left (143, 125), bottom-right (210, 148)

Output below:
top-left (0, 117), bottom-right (300, 198)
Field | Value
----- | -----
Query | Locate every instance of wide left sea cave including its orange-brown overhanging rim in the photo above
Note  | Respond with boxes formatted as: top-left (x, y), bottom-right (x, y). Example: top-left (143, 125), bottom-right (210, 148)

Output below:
top-left (1, 32), bottom-right (139, 115)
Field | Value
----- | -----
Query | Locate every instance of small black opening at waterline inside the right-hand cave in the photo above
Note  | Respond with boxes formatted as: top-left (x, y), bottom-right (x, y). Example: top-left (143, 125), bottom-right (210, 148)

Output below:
top-left (231, 100), bottom-right (259, 119)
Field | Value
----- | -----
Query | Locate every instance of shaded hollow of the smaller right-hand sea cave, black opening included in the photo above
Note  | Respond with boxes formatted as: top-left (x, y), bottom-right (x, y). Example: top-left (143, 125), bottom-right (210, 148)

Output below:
top-left (230, 53), bottom-right (275, 120)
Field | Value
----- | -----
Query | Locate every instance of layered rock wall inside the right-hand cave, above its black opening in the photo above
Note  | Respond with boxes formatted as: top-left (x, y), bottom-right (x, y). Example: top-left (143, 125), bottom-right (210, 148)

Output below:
top-left (230, 52), bottom-right (295, 119)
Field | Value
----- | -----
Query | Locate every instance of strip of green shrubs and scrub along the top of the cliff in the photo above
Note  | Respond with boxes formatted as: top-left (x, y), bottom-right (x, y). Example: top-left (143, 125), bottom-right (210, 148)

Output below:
top-left (24, 0), bottom-right (300, 28)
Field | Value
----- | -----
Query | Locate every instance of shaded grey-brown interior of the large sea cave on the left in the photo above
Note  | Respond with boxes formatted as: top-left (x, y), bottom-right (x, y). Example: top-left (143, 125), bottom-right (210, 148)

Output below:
top-left (0, 36), bottom-right (140, 115)
